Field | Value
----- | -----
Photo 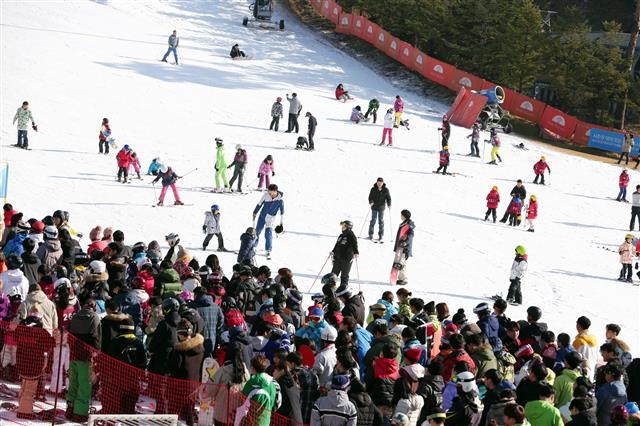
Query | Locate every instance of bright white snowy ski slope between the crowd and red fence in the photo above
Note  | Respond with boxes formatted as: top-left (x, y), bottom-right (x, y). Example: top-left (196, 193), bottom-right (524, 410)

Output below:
top-left (0, 0), bottom-right (640, 360)
